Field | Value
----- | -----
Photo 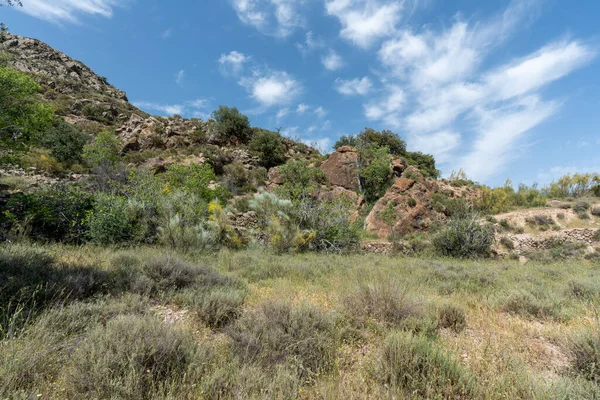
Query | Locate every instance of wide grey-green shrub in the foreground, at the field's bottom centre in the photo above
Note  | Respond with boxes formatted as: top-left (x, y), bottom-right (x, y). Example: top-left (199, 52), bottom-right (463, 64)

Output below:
top-left (229, 302), bottom-right (337, 379)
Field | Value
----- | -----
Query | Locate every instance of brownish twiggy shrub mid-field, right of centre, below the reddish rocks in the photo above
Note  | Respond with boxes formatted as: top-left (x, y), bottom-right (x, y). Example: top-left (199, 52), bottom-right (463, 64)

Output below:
top-left (344, 281), bottom-right (423, 326)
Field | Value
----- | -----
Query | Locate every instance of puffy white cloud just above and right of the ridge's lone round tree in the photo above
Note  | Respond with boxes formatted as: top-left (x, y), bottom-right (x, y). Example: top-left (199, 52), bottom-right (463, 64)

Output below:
top-left (239, 71), bottom-right (302, 108)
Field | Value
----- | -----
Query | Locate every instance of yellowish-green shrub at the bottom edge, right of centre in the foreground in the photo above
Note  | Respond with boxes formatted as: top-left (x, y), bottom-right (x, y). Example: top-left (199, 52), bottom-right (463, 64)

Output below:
top-left (376, 332), bottom-right (474, 399)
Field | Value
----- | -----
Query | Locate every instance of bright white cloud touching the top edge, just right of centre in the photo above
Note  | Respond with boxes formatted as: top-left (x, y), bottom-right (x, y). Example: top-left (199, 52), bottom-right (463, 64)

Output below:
top-left (325, 0), bottom-right (403, 48)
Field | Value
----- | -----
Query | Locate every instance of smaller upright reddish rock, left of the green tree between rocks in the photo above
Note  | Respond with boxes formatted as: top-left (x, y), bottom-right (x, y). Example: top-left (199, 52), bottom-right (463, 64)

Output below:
top-left (321, 146), bottom-right (360, 191)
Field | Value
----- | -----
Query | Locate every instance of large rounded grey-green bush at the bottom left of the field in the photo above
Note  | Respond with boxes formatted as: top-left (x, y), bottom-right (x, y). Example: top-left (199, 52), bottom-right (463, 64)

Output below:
top-left (67, 316), bottom-right (195, 399)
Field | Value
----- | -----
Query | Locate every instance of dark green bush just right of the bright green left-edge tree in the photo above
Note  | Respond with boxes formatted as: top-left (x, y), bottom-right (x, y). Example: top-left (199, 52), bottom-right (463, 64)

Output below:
top-left (37, 118), bottom-right (89, 165)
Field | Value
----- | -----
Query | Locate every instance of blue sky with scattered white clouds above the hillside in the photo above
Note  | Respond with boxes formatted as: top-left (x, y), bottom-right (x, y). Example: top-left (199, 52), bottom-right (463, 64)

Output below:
top-left (0, 0), bottom-right (600, 185)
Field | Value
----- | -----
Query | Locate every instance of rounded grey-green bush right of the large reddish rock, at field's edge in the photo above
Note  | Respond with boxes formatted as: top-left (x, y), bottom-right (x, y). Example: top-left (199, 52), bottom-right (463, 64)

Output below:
top-left (433, 215), bottom-right (494, 258)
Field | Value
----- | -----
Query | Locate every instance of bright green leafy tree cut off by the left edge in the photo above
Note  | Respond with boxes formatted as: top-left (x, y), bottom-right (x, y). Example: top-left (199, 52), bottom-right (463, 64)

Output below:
top-left (0, 67), bottom-right (54, 143)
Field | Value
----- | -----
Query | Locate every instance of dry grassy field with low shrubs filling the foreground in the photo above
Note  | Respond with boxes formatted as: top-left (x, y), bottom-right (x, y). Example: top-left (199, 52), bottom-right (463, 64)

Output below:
top-left (0, 245), bottom-right (600, 399)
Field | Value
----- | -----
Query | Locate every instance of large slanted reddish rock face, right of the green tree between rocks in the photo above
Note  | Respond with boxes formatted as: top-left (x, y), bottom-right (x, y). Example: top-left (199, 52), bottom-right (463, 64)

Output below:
top-left (365, 167), bottom-right (446, 238)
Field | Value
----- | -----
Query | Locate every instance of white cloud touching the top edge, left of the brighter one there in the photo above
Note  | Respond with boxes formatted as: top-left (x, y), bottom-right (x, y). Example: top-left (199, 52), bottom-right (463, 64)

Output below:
top-left (233, 0), bottom-right (306, 37)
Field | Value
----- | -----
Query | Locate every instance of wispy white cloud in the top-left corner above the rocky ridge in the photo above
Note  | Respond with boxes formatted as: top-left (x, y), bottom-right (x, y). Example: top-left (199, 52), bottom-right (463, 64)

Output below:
top-left (17, 0), bottom-right (122, 23)
